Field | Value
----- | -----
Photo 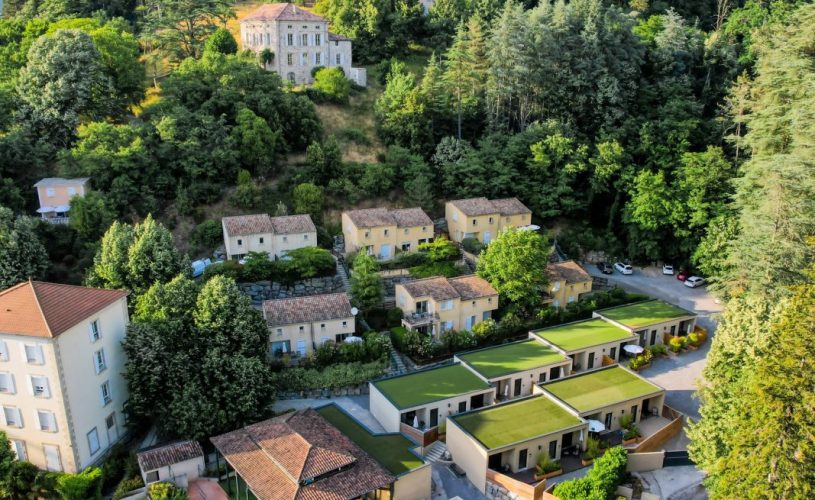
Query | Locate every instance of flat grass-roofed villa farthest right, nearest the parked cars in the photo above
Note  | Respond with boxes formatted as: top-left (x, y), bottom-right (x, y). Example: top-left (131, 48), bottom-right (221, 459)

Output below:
top-left (594, 299), bottom-right (696, 347)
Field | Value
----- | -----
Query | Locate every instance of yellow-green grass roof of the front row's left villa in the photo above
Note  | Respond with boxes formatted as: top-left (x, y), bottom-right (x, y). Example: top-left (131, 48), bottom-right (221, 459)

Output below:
top-left (448, 396), bottom-right (580, 450)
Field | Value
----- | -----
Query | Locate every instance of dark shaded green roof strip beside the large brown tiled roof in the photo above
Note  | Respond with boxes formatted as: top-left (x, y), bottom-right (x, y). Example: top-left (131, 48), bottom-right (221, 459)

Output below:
top-left (317, 405), bottom-right (424, 476)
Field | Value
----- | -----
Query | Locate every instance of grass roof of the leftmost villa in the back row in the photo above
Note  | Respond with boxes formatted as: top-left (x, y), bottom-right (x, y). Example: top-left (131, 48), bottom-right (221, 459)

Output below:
top-left (374, 364), bottom-right (490, 409)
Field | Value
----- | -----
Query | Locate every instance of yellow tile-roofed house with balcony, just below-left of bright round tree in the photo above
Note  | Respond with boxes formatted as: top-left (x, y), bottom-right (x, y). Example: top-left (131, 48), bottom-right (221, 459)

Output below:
top-left (395, 274), bottom-right (498, 338)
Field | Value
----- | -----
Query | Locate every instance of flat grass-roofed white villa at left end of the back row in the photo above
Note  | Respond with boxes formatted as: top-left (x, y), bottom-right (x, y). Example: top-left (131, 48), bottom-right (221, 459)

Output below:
top-left (369, 363), bottom-right (495, 432)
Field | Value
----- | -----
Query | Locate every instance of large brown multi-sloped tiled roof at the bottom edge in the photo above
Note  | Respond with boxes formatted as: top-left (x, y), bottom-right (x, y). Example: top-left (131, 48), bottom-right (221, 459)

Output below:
top-left (211, 408), bottom-right (396, 500)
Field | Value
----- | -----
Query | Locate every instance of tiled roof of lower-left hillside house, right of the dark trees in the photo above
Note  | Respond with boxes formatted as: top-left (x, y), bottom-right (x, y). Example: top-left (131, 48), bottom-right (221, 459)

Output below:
top-left (263, 293), bottom-right (353, 326)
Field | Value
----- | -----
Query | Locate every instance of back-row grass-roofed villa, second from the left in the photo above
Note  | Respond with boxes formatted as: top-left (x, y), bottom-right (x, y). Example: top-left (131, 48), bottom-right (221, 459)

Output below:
top-left (455, 339), bottom-right (572, 400)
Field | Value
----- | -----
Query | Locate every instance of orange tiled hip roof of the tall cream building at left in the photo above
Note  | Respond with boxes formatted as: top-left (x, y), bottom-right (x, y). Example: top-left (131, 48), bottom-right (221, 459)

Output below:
top-left (0, 281), bottom-right (127, 337)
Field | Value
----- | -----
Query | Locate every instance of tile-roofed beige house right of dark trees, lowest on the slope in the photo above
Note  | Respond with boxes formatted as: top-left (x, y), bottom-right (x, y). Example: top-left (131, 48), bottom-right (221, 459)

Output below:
top-left (263, 293), bottom-right (355, 356)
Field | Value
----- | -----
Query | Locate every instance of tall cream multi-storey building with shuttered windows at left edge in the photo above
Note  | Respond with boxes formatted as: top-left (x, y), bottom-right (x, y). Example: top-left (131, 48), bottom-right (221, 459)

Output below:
top-left (0, 281), bottom-right (129, 473)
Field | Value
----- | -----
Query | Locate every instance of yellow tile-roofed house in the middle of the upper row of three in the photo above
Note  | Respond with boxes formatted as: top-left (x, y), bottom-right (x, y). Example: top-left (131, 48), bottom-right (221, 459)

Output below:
top-left (342, 208), bottom-right (433, 260)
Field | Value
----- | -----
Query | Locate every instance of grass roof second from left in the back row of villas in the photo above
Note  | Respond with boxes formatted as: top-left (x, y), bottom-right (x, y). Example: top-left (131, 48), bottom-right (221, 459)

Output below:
top-left (459, 339), bottom-right (567, 379)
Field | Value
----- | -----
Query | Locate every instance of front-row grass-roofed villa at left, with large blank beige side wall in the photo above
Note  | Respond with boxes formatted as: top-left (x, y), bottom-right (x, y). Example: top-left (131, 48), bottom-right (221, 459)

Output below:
top-left (447, 395), bottom-right (588, 492)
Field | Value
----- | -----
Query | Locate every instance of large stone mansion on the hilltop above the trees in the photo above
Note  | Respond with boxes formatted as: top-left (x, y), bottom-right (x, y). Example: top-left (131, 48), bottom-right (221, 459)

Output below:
top-left (241, 3), bottom-right (367, 86)
